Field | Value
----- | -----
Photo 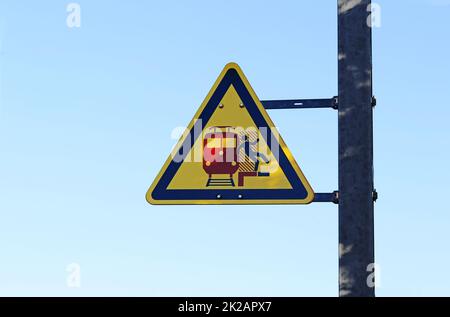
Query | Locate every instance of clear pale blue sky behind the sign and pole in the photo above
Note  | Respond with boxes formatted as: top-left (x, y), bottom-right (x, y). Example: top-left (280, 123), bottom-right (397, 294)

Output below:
top-left (0, 0), bottom-right (450, 296)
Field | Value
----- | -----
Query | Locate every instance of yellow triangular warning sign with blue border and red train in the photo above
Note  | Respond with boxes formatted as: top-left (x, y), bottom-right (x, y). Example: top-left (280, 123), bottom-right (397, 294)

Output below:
top-left (146, 63), bottom-right (314, 204)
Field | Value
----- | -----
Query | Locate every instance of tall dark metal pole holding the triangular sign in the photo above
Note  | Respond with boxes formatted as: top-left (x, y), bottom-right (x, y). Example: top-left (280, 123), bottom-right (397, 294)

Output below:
top-left (338, 0), bottom-right (375, 296)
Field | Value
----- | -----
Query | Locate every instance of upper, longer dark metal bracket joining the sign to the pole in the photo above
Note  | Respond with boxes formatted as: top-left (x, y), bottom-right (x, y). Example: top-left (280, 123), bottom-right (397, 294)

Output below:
top-left (261, 96), bottom-right (339, 110)
